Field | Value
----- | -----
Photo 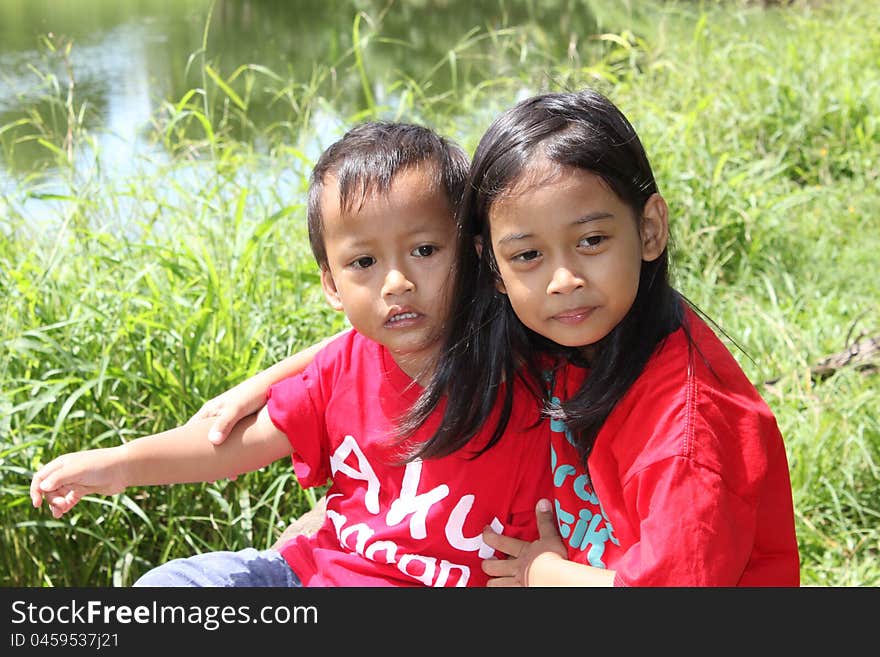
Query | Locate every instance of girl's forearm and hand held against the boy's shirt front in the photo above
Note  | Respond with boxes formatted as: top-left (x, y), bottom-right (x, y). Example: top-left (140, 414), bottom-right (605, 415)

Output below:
top-left (482, 500), bottom-right (616, 586)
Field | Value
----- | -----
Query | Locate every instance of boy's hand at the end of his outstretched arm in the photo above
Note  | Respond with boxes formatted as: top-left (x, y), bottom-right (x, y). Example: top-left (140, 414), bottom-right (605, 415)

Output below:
top-left (31, 447), bottom-right (126, 518)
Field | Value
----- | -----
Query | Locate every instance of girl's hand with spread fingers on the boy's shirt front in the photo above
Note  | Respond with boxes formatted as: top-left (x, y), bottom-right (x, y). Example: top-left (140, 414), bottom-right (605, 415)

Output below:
top-left (482, 500), bottom-right (568, 586)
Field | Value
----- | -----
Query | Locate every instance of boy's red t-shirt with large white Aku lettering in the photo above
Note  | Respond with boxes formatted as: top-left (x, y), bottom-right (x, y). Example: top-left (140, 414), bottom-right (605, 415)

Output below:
top-left (268, 331), bottom-right (551, 586)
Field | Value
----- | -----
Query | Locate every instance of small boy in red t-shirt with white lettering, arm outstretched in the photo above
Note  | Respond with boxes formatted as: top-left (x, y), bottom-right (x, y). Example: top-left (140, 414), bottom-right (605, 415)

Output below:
top-left (31, 122), bottom-right (550, 586)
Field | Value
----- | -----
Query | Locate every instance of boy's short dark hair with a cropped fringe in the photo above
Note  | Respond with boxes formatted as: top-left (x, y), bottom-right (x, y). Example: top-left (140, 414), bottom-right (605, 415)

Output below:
top-left (307, 121), bottom-right (468, 268)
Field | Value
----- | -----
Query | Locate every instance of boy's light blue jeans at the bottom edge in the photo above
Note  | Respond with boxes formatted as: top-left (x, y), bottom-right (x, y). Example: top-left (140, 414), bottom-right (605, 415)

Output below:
top-left (134, 548), bottom-right (302, 587)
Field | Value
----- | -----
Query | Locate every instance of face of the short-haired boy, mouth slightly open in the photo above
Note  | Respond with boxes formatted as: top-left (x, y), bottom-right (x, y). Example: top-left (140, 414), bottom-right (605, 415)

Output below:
top-left (321, 168), bottom-right (456, 378)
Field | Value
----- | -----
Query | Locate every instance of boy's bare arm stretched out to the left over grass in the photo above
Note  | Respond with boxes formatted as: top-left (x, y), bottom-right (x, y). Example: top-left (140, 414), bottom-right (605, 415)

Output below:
top-left (30, 407), bottom-right (291, 518)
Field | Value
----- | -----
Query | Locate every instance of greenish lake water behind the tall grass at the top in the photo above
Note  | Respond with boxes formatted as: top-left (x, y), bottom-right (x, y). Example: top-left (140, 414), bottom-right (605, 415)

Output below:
top-left (0, 0), bottom-right (616, 222)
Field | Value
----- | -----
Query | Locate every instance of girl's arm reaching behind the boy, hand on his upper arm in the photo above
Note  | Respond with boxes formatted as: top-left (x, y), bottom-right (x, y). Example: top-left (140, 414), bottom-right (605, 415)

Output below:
top-left (189, 331), bottom-right (345, 445)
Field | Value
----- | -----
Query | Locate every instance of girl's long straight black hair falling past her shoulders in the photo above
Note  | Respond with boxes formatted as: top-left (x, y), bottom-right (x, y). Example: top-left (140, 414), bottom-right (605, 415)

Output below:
top-left (400, 89), bottom-right (683, 463)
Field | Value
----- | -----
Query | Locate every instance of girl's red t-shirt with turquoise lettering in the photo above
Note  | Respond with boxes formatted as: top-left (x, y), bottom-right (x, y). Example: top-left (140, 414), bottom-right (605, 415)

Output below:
top-left (551, 309), bottom-right (800, 586)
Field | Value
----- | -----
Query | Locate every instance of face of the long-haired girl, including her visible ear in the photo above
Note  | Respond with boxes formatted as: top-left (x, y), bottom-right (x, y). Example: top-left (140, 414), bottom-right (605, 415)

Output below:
top-left (489, 160), bottom-right (668, 347)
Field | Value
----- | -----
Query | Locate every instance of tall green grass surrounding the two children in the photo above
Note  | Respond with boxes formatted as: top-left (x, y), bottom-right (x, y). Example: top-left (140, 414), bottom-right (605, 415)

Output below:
top-left (0, 0), bottom-right (880, 586)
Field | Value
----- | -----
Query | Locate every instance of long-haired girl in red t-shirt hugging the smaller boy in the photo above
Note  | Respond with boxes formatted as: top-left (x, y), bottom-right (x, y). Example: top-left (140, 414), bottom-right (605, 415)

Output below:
top-left (408, 90), bottom-right (799, 586)
